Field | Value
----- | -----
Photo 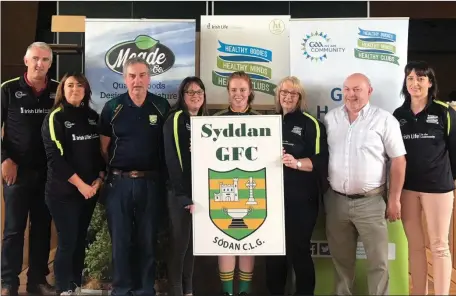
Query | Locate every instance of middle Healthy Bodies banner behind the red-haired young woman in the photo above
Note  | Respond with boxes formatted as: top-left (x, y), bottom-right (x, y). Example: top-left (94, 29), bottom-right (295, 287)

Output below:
top-left (200, 15), bottom-right (290, 107)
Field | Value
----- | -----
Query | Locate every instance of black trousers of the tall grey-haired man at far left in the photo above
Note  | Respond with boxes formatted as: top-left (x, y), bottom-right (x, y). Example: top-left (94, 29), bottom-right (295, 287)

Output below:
top-left (1, 167), bottom-right (51, 289)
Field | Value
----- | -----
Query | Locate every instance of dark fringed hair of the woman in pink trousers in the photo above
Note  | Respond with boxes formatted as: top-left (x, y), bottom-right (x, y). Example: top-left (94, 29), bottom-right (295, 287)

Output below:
top-left (401, 61), bottom-right (438, 101)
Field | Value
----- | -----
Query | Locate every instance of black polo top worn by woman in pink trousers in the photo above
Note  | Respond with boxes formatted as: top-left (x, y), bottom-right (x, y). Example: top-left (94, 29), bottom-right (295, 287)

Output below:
top-left (393, 100), bottom-right (456, 193)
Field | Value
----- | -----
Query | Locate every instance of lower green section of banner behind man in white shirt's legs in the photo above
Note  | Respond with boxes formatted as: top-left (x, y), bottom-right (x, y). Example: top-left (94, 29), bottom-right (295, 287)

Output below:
top-left (312, 200), bottom-right (410, 295)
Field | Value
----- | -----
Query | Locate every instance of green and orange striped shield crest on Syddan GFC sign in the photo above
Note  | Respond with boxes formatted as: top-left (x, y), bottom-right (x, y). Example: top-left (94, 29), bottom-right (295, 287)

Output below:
top-left (209, 168), bottom-right (267, 241)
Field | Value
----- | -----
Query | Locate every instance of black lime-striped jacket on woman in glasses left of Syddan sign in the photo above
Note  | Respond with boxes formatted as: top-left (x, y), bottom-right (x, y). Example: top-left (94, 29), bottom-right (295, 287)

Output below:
top-left (163, 110), bottom-right (193, 207)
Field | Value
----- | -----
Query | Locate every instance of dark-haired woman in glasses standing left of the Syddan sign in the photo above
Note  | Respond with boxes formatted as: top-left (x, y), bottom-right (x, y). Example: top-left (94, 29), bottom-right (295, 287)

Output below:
top-left (163, 77), bottom-right (207, 296)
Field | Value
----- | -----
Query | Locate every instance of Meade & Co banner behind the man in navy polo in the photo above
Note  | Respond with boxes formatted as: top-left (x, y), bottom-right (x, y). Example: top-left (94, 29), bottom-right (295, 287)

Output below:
top-left (85, 19), bottom-right (196, 112)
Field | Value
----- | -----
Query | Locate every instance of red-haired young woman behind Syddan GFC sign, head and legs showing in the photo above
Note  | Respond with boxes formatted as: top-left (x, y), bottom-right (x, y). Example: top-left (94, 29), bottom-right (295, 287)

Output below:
top-left (214, 71), bottom-right (261, 296)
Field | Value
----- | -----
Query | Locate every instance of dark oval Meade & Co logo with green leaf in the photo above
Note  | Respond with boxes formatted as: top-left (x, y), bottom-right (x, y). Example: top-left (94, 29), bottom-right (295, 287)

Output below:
top-left (105, 35), bottom-right (176, 76)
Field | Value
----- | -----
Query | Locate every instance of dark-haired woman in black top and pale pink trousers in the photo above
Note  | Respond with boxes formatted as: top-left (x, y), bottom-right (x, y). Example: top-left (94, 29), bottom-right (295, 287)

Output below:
top-left (394, 62), bottom-right (456, 295)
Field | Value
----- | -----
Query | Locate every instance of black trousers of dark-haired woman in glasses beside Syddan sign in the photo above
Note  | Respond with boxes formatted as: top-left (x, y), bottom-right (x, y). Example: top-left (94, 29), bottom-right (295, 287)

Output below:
top-left (168, 194), bottom-right (194, 296)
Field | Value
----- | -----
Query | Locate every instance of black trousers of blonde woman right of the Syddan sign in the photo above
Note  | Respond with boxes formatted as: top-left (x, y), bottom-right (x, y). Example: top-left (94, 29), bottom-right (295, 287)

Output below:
top-left (266, 196), bottom-right (319, 296)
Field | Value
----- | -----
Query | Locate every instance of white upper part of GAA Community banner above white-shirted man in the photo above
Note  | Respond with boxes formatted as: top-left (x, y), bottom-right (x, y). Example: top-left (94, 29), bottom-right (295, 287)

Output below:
top-left (290, 18), bottom-right (408, 119)
